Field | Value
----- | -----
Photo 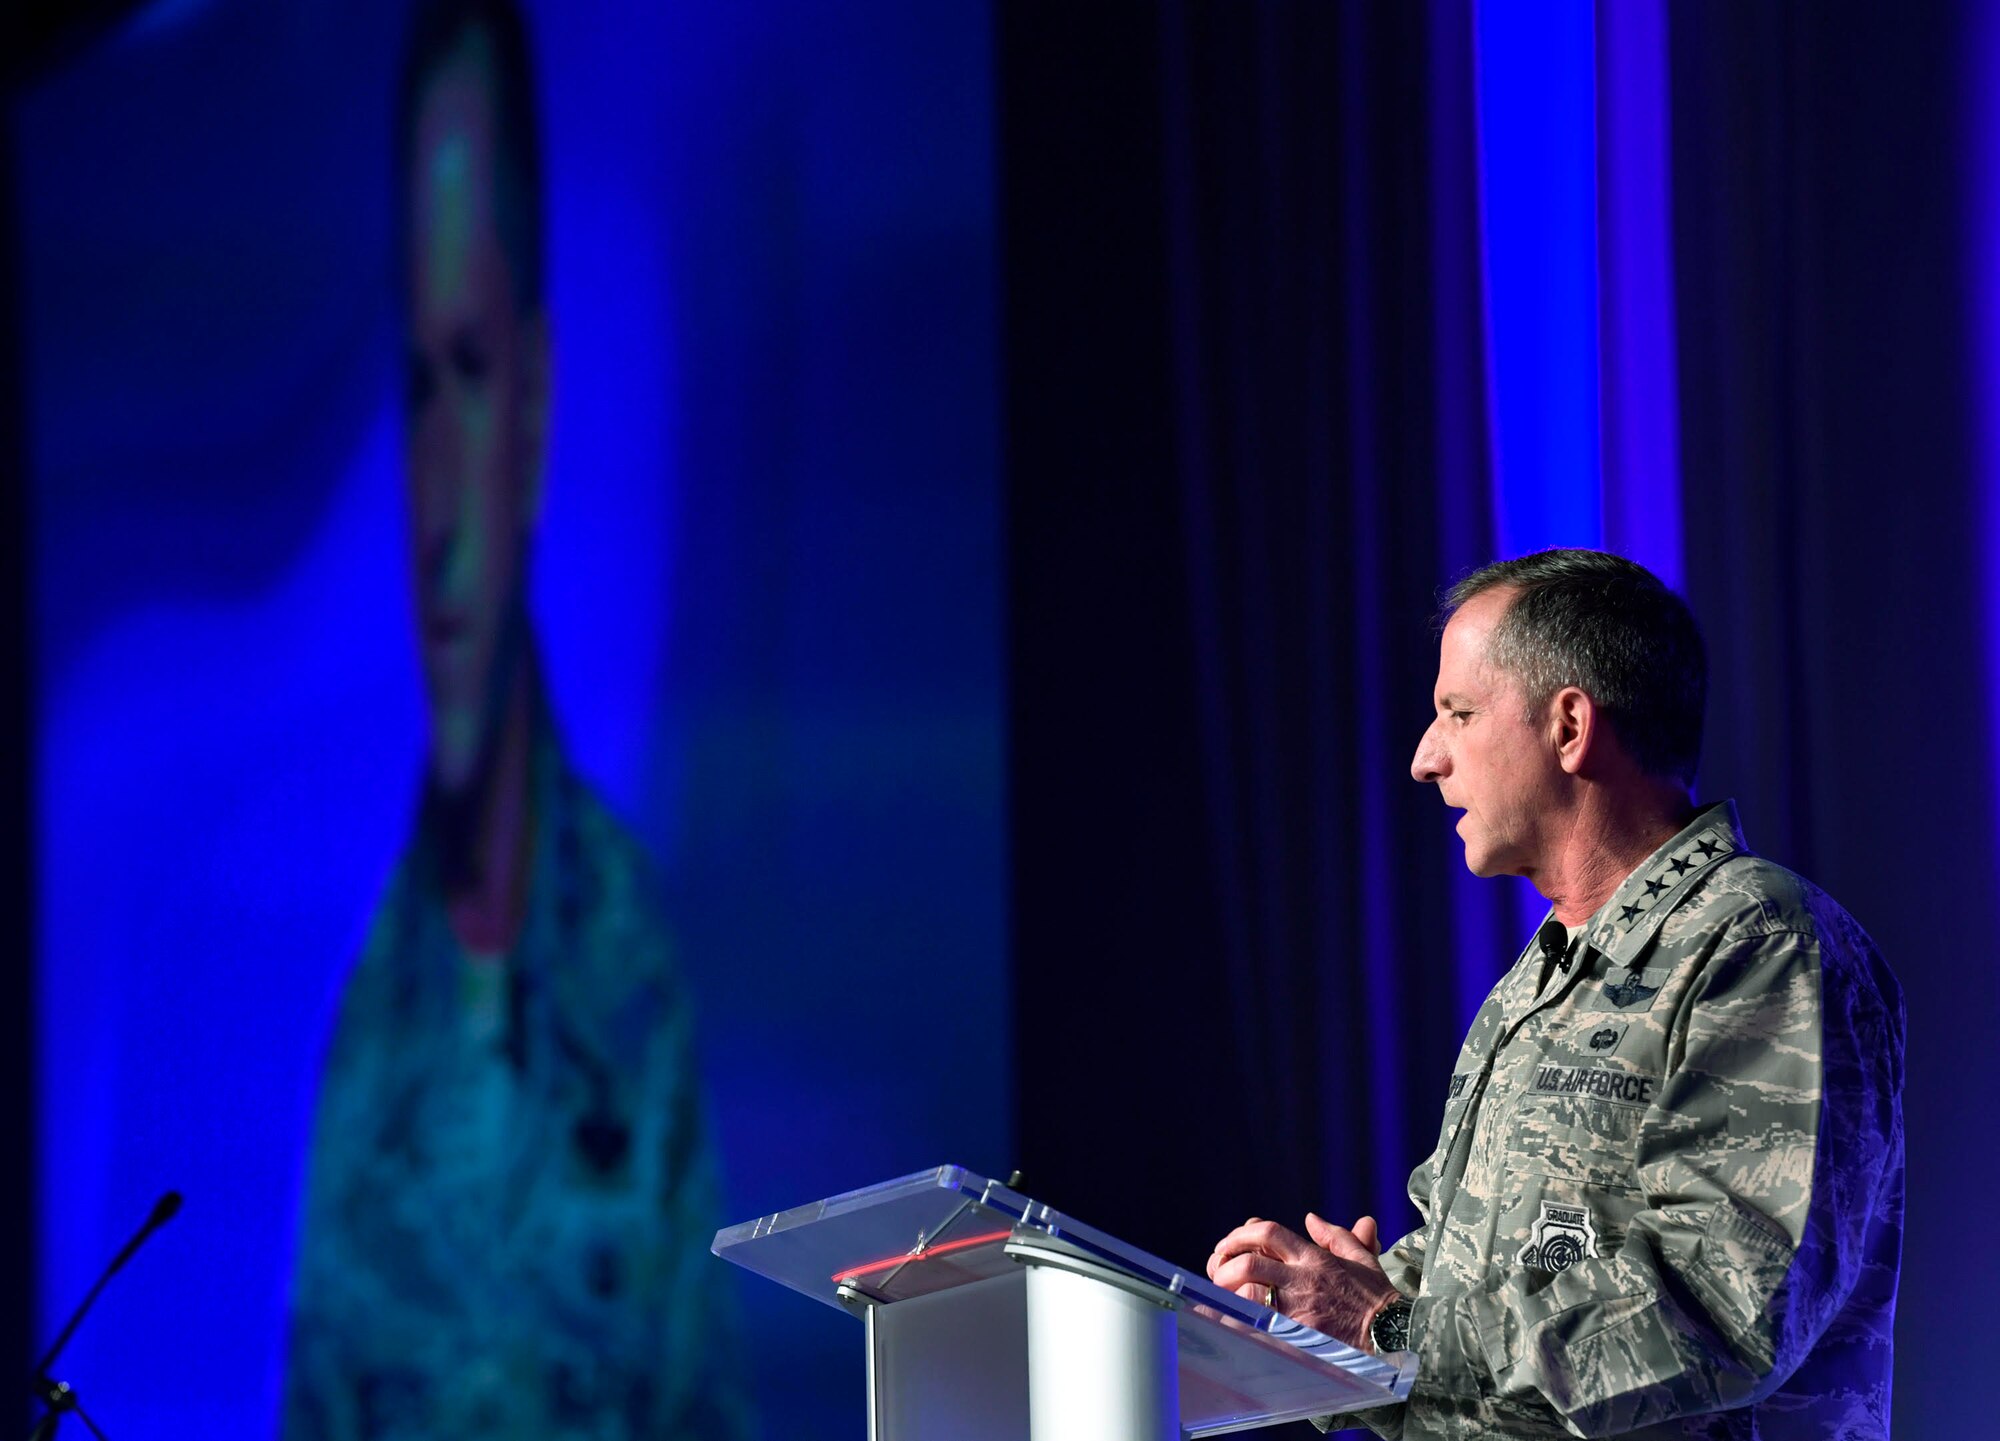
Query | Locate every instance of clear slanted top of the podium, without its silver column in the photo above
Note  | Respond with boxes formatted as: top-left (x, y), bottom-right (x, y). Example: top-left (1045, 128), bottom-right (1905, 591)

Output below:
top-left (712, 1165), bottom-right (1416, 1435)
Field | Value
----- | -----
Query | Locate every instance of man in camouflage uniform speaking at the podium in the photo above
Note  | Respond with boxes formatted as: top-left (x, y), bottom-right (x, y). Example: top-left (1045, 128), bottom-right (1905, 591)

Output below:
top-left (1210, 550), bottom-right (1904, 1441)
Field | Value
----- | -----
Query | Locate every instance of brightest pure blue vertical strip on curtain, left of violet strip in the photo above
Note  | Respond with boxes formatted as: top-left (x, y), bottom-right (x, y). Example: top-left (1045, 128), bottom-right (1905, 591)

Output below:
top-left (1474, 0), bottom-right (1604, 556)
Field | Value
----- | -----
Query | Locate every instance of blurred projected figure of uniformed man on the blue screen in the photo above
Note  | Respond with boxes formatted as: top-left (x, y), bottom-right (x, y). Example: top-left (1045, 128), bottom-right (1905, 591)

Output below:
top-left (284, 0), bottom-right (746, 1439)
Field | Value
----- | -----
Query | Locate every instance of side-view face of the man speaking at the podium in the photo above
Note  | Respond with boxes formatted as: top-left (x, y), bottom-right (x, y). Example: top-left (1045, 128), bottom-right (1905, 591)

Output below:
top-left (1410, 588), bottom-right (1562, 877)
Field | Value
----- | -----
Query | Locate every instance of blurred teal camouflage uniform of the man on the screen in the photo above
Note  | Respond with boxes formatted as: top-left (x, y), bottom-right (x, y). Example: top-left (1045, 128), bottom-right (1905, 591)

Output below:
top-left (284, 716), bottom-right (748, 1441)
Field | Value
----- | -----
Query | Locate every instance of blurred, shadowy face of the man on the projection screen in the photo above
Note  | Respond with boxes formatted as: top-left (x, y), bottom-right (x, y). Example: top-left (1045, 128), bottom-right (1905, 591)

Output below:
top-left (404, 32), bottom-right (548, 795)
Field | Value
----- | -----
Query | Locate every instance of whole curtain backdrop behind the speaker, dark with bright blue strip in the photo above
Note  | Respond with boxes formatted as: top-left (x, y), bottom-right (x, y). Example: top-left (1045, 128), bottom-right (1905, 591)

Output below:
top-left (1000, 0), bottom-right (2000, 1437)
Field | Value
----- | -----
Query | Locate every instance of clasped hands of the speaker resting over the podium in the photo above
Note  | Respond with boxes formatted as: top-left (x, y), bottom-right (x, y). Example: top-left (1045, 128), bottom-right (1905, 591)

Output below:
top-left (1208, 1215), bottom-right (1396, 1351)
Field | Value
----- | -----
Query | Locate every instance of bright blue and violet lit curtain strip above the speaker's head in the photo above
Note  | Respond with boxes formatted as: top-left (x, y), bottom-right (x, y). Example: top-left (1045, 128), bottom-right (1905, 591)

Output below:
top-left (1462, 0), bottom-right (1682, 968)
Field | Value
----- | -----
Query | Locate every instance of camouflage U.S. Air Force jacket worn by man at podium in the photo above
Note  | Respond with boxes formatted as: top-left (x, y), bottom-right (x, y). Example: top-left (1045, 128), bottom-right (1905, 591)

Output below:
top-left (1364, 803), bottom-right (1904, 1441)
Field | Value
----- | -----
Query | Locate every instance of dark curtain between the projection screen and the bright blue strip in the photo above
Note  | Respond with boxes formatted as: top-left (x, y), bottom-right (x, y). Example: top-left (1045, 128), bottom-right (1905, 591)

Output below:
top-left (1000, 4), bottom-right (1520, 1336)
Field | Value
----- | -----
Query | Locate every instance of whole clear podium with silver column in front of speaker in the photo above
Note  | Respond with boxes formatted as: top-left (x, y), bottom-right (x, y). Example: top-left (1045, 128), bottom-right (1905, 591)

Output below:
top-left (714, 1167), bottom-right (1416, 1441)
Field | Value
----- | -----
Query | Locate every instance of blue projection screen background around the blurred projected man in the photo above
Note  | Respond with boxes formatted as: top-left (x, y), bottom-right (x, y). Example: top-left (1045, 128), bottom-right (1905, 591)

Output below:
top-left (19, 0), bottom-right (1010, 1437)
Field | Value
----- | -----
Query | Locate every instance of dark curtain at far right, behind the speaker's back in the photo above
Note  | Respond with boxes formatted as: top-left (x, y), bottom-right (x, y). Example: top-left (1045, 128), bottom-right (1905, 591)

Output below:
top-left (1670, 0), bottom-right (2000, 1435)
